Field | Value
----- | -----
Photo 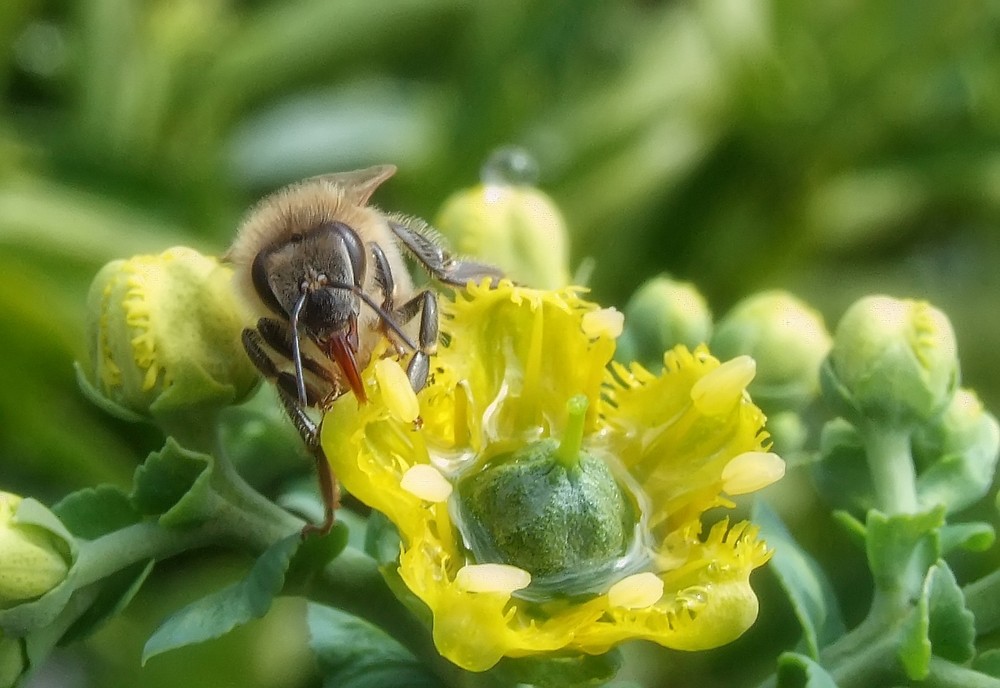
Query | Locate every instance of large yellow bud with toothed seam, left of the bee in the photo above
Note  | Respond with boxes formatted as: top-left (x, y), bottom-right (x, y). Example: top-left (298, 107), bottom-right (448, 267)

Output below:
top-left (82, 247), bottom-right (258, 420)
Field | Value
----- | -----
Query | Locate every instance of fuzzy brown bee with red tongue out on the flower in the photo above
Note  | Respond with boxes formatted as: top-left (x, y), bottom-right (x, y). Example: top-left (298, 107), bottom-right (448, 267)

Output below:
top-left (225, 165), bottom-right (502, 534)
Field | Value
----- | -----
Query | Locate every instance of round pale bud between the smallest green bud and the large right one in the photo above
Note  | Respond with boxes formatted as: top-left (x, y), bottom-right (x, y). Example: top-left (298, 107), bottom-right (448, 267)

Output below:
top-left (710, 291), bottom-right (830, 413)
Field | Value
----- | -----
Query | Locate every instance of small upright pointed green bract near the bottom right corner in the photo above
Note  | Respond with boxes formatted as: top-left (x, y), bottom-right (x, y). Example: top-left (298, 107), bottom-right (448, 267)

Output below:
top-left (897, 560), bottom-right (976, 681)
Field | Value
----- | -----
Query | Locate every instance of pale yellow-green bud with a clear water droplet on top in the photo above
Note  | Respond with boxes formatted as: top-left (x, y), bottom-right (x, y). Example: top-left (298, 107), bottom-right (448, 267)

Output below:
top-left (436, 182), bottom-right (570, 289)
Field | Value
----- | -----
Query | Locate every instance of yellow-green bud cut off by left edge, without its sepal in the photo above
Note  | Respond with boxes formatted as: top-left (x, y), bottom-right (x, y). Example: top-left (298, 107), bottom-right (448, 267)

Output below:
top-left (0, 492), bottom-right (69, 609)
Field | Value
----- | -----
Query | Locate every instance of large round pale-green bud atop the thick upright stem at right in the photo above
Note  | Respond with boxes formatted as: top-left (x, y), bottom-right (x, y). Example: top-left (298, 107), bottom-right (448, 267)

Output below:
top-left (821, 296), bottom-right (959, 425)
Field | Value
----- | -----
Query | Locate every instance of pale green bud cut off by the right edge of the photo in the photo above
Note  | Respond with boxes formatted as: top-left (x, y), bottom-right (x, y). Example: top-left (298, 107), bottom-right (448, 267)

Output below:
top-left (913, 389), bottom-right (1000, 513)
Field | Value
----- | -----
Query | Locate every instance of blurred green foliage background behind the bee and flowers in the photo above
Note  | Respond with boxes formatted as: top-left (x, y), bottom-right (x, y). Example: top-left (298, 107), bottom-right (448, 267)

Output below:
top-left (0, 0), bottom-right (1000, 688)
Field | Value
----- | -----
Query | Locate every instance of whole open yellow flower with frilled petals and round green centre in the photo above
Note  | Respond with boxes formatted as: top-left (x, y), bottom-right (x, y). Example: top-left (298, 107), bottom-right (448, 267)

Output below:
top-left (322, 282), bottom-right (783, 671)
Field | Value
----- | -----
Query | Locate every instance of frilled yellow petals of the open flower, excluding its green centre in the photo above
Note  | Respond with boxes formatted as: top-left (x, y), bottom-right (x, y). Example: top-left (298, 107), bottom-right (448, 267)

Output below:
top-left (322, 282), bottom-right (769, 671)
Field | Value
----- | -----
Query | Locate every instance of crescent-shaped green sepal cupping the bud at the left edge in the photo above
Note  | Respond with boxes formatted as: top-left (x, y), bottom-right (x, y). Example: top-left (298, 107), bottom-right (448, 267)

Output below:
top-left (0, 497), bottom-right (79, 636)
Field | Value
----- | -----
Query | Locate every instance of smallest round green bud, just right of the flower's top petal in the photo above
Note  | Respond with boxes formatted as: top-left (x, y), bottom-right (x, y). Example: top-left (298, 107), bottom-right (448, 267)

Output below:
top-left (615, 275), bottom-right (712, 369)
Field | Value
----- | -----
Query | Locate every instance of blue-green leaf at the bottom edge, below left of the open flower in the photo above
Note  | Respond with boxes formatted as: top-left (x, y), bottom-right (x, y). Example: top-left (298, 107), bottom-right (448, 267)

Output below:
top-left (307, 604), bottom-right (441, 688)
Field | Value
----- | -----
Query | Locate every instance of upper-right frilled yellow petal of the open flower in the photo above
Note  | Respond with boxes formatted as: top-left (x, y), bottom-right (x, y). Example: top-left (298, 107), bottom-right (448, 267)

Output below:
top-left (604, 346), bottom-right (768, 533)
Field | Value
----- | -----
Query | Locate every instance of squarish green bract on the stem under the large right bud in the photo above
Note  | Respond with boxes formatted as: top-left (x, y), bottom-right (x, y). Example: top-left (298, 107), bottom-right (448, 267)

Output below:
top-left (867, 507), bottom-right (944, 600)
